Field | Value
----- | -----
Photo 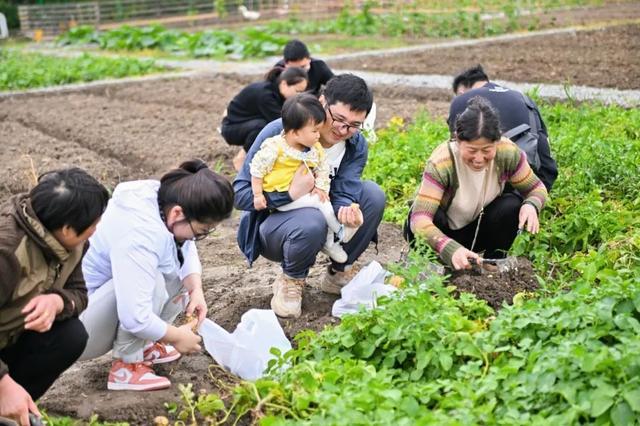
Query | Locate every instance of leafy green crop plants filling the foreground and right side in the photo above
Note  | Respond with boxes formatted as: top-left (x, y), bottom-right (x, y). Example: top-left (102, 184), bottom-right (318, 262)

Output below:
top-left (169, 100), bottom-right (640, 425)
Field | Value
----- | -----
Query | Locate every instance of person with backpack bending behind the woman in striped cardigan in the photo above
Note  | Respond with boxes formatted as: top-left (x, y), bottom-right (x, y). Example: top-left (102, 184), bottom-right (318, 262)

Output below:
top-left (447, 65), bottom-right (558, 192)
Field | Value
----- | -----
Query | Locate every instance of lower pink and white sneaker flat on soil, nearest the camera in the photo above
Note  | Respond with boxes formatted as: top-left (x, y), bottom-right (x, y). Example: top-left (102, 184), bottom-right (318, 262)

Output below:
top-left (107, 359), bottom-right (171, 391)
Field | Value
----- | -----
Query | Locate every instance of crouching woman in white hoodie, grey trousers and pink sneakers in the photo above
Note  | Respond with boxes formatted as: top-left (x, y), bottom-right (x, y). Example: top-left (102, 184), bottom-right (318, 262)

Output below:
top-left (80, 160), bottom-right (233, 391)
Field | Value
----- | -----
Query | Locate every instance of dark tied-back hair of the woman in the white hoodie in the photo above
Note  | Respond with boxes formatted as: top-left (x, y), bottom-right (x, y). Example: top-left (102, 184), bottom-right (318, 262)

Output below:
top-left (158, 159), bottom-right (233, 223)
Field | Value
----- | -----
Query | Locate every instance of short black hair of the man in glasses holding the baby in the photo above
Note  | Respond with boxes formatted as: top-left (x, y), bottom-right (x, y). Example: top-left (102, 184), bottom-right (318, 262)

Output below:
top-left (323, 74), bottom-right (373, 114)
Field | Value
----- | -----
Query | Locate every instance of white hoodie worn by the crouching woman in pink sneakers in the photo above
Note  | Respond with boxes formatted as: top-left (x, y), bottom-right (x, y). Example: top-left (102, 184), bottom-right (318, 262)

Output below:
top-left (82, 180), bottom-right (202, 341)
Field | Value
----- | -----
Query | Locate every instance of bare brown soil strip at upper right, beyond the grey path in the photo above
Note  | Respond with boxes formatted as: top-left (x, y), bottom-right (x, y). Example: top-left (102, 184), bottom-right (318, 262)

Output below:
top-left (330, 22), bottom-right (640, 89)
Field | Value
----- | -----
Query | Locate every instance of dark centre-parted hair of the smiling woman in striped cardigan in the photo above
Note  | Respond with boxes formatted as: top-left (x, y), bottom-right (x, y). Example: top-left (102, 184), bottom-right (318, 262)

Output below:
top-left (455, 96), bottom-right (501, 142)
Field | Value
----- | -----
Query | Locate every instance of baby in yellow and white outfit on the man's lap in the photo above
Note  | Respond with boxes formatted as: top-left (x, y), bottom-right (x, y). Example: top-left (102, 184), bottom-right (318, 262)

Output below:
top-left (250, 94), bottom-right (354, 263)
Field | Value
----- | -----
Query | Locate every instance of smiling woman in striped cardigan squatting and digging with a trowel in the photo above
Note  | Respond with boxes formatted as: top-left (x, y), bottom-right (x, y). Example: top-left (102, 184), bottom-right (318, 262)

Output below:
top-left (409, 97), bottom-right (547, 269)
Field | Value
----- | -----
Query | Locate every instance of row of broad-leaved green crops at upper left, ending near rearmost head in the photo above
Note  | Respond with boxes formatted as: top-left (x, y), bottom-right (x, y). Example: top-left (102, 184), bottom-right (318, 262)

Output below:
top-left (57, 25), bottom-right (287, 59)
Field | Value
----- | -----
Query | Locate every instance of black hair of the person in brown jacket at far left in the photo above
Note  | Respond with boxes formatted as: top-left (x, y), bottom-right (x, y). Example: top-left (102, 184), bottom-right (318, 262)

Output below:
top-left (29, 167), bottom-right (109, 235)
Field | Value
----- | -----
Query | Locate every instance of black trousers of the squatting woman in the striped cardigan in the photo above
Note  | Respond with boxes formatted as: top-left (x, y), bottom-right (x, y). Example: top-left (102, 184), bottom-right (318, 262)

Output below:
top-left (403, 192), bottom-right (522, 259)
